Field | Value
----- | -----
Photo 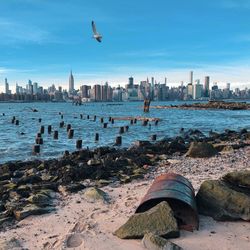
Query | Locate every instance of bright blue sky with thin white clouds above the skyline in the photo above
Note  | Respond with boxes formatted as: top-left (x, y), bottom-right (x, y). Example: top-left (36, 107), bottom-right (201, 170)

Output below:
top-left (0, 0), bottom-right (250, 91)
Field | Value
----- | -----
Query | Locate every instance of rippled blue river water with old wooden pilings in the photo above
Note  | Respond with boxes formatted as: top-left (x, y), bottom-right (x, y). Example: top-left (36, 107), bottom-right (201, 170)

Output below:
top-left (0, 102), bottom-right (250, 163)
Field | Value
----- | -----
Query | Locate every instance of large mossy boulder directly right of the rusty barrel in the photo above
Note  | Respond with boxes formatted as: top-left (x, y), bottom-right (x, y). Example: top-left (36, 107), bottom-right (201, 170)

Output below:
top-left (196, 180), bottom-right (250, 221)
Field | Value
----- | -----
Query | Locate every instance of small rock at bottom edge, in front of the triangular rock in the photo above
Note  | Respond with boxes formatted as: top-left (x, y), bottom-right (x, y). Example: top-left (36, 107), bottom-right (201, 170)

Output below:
top-left (142, 233), bottom-right (182, 250)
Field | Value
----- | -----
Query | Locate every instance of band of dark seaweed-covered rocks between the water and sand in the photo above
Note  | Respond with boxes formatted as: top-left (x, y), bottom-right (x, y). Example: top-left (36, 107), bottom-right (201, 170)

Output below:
top-left (0, 129), bottom-right (250, 227)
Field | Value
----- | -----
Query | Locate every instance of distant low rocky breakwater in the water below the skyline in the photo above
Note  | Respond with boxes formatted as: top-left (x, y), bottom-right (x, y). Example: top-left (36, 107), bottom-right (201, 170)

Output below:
top-left (151, 101), bottom-right (250, 110)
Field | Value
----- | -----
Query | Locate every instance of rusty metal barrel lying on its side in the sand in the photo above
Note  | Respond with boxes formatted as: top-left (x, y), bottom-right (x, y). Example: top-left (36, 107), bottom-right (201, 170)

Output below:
top-left (136, 173), bottom-right (199, 231)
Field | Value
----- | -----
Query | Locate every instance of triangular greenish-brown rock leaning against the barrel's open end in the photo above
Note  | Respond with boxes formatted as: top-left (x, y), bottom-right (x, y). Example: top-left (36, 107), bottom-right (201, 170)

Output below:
top-left (114, 201), bottom-right (179, 239)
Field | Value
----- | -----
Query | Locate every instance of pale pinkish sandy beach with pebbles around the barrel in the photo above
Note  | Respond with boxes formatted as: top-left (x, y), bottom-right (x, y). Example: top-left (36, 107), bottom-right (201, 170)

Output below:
top-left (0, 146), bottom-right (250, 250)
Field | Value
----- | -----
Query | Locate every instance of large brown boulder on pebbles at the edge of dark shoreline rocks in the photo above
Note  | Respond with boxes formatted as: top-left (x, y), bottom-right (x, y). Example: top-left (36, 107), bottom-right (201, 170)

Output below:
top-left (186, 142), bottom-right (218, 158)
